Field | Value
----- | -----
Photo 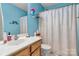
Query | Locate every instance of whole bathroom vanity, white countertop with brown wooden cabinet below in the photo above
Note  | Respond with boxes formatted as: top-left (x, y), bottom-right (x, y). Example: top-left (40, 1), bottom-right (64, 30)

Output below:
top-left (0, 36), bottom-right (41, 56)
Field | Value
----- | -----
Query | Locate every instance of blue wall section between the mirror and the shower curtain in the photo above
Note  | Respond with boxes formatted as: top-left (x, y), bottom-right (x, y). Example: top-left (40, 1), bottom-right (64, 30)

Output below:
top-left (28, 3), bottom-right (44, 36)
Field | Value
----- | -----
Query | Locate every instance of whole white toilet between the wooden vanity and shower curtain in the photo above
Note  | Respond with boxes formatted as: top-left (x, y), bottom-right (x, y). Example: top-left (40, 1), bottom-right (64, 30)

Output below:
top-left (41, 44), bottom-right (51, 56)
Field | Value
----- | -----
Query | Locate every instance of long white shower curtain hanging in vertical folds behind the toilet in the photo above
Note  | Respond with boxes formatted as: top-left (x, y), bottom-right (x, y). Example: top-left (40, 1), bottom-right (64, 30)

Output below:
top-left (39, 5), bottom-right (77, 56)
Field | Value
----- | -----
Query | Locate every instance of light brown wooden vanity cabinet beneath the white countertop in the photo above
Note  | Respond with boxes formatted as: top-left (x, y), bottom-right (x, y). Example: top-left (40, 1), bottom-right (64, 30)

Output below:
top-left (12, 40), bottom-right (41, 56)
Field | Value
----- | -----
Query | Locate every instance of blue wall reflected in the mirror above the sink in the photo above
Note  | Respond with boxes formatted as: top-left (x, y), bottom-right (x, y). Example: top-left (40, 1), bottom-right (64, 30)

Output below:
top-left (2, 3), bottom-right (27, 34)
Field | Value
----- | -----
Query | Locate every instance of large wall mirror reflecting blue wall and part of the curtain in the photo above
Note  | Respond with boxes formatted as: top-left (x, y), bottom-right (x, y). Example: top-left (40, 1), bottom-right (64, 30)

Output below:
top-left (0, 3), bottom-right (27, 39)
